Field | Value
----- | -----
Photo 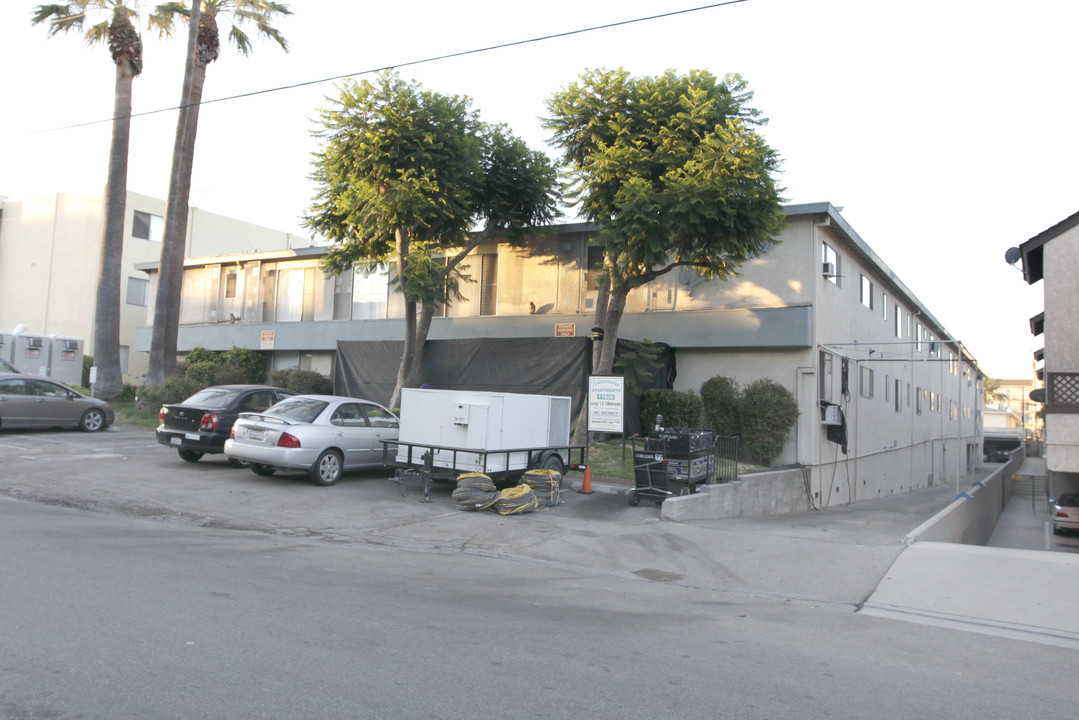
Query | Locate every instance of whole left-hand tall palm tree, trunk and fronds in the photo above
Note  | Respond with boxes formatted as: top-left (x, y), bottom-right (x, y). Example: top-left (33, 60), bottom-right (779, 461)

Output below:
top-left (32, 0), bottom-right (142, 399)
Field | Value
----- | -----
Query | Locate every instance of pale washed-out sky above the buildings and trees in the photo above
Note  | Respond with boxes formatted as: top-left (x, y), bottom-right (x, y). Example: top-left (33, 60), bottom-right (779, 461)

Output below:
top-left (0, 0), bottom-right (1079, 378)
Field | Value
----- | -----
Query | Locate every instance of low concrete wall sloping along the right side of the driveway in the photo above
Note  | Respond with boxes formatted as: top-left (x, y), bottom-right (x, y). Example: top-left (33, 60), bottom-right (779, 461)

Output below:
top-left (904, 448), bottom-right (1026, 545)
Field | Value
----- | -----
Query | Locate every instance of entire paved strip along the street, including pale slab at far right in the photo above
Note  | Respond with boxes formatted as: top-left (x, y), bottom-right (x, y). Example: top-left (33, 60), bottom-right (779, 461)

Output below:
top-left (6, 425), bottom-right (1079, 647)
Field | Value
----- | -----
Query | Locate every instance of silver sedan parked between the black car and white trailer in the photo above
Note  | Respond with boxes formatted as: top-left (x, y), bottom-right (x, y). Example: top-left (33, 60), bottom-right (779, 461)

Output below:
top-left (224, 395), bottom-right (399, 485)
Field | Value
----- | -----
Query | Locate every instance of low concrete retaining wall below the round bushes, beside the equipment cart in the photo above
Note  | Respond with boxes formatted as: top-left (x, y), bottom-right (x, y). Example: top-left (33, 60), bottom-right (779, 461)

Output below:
top-left (660, 467), bottom-right (810, 521)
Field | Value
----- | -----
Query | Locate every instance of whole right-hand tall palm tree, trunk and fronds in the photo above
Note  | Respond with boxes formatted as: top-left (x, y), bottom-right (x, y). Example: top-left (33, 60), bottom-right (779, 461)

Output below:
top-left (147, 0), bottom-right (292, 384)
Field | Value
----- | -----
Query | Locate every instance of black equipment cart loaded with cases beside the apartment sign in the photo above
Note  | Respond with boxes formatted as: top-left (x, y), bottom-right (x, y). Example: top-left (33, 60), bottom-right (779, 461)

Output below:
top-left (629, 429), bottom-right (715, 505)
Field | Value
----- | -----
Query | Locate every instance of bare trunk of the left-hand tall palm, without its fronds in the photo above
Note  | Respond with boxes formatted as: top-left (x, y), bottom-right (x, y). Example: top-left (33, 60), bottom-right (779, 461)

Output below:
top-left (94, 60), bottom-right (137, 399)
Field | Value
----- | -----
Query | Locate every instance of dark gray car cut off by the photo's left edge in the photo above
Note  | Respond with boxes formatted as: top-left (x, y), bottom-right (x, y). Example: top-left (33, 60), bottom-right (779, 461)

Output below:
top-left (0, 372), bottom-right (115, 433)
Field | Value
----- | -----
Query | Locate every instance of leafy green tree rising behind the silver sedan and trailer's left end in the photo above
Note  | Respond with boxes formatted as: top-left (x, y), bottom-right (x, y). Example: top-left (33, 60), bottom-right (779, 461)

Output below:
top-left (306, 72), bottom-right (557, 406)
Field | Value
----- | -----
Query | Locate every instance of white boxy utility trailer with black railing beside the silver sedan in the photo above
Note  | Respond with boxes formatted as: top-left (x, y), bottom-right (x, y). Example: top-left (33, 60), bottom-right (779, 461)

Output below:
top-left (383, 389), bottom-right (585, 498)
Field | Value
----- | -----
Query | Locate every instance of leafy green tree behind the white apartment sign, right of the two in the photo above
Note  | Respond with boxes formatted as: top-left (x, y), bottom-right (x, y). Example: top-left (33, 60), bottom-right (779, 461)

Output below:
top-left (544, 69), bottom-right (783, 373)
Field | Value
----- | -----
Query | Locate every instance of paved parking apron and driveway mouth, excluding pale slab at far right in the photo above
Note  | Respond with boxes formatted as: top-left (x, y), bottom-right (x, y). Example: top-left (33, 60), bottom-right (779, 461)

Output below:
top-left (0, 425), bottom-right (944, 609)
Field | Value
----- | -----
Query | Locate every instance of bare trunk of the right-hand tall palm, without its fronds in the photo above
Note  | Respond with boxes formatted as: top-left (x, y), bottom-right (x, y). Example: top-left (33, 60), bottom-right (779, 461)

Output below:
top-left (147, 0), bottom-right (200, 384)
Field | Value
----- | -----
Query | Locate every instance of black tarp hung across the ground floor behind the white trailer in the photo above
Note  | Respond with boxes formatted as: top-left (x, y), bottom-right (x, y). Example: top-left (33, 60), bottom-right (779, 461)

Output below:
top-left (333, 338), bottom-right (674, 435)
